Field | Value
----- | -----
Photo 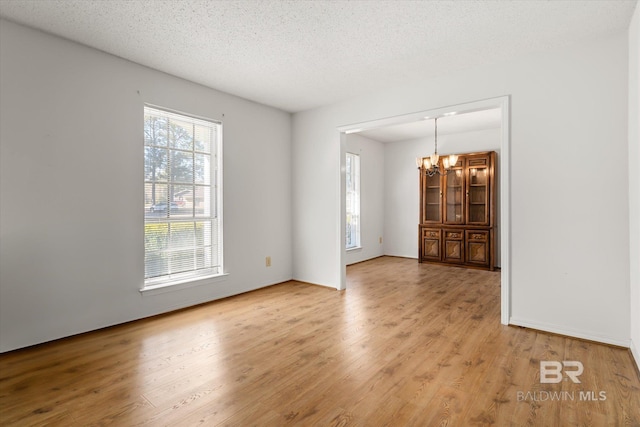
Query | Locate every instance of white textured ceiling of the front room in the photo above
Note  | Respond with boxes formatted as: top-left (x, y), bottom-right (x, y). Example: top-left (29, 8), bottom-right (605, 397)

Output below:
top-left (0, 0), bottom-right (636, 112)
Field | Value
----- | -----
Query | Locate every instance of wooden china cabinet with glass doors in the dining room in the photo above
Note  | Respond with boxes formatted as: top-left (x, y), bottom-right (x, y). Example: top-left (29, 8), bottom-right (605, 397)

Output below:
top-left (418, 151), bottom-right (496, 270)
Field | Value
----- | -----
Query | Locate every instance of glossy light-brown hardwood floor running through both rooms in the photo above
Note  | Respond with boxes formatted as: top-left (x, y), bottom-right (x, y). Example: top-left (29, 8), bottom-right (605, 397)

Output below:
top-left (0, 257), bottom-right (640, 426)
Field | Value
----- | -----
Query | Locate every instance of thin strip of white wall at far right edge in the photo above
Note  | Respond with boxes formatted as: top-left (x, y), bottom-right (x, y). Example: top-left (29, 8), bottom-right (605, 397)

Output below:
top-left (629, 5), bottom-right (640, 367)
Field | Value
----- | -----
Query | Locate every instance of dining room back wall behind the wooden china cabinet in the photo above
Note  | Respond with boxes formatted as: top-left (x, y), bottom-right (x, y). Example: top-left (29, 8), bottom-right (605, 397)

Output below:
top-left (384, 129), bottom-right (500, 266)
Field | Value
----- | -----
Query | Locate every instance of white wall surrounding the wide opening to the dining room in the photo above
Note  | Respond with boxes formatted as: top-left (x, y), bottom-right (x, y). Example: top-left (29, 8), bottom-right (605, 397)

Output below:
top-left (293, 34), bottom-right (630, 345)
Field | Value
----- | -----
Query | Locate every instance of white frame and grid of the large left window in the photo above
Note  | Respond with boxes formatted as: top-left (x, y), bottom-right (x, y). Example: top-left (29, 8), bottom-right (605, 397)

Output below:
top-left (141, 104), bottom-right (224, 291)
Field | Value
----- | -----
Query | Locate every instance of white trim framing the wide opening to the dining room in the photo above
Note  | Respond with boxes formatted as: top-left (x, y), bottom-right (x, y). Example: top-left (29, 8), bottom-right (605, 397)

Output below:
top-left (338, 95), bottom-right (511, 325)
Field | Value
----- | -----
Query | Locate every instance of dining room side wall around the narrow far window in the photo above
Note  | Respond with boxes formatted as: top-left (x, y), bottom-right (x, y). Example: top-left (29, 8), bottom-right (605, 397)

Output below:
top-left (346, 134), bottom-right (385, 265)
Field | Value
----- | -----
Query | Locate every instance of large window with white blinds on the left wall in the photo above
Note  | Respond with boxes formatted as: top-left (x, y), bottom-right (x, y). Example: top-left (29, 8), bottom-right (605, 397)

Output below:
top-left (144, 106), bottom-right (223, 289)
